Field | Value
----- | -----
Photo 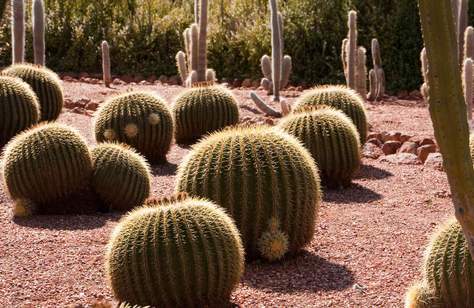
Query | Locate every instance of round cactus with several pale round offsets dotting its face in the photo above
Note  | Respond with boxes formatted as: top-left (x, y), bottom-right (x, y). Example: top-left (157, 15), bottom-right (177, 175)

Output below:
top-left (95, 92), bottom-right (174, 163)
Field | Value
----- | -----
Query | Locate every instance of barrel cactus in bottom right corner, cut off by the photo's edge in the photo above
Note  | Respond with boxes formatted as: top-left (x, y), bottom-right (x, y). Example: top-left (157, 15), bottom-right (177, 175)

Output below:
top-left (406, 219), bottom-right (474, 308)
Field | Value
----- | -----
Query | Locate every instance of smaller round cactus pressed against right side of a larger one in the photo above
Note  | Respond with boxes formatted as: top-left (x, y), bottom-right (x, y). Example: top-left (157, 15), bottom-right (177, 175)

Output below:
top-left (92, 143), bottom-right (151, 211)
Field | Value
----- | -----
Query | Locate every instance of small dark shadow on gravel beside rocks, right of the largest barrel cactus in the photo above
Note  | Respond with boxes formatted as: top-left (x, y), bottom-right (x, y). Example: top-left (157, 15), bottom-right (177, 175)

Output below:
top-left (323, 183), bottom-right (383, 203)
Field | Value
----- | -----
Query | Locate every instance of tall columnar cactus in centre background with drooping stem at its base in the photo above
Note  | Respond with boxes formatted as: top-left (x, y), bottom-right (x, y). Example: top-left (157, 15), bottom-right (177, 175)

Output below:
top-left (250, 0), bottom-right (292, 117)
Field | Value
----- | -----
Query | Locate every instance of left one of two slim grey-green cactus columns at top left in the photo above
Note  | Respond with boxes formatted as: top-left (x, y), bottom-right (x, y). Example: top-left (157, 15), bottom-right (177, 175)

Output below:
top-left (12, 0), bottom-right (25, 64)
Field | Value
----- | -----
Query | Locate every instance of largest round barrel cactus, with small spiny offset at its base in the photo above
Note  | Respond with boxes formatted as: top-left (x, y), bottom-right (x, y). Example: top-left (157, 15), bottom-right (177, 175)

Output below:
top-left (176, 126), bottom-right (320, 261)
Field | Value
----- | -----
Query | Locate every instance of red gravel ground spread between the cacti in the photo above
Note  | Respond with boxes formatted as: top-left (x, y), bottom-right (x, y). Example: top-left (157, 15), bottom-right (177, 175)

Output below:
top-left (0, 82), bottom-right (453, 307)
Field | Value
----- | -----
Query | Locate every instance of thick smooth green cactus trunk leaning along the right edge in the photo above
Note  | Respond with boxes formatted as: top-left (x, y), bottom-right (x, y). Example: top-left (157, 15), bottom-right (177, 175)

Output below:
top-left (419, 0), bottom-right (474, 259)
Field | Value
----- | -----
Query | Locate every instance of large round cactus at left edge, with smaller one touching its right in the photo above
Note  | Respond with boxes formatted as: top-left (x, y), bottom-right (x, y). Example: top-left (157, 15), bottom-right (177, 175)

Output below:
top-left (2, 123), bottom-right (92, 212)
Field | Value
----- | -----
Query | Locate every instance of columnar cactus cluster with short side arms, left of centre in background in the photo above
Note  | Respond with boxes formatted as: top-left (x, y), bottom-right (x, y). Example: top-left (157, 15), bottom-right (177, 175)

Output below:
top-left (176, 0), bottom-right (216, 87)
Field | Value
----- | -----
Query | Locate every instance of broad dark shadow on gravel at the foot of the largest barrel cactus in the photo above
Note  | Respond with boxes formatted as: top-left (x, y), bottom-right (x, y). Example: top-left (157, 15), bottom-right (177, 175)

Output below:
top-left (243, 251), bottom-right (354, 293)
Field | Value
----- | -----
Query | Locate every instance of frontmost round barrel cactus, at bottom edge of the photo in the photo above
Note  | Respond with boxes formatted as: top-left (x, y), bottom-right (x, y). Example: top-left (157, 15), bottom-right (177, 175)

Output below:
top-left (106, 198), bottom-right (244, 307)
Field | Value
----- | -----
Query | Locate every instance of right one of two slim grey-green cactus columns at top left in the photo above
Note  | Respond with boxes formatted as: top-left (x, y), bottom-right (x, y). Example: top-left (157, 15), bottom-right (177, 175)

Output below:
top-left (32, 0), bottom-right (46, 66)
